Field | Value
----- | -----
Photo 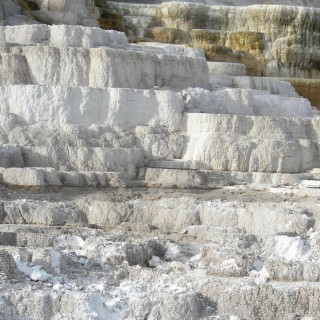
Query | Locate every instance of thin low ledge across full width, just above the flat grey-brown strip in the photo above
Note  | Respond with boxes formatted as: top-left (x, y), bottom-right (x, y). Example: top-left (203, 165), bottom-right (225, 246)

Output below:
top-left (0, 165), bottom-right (318, 190)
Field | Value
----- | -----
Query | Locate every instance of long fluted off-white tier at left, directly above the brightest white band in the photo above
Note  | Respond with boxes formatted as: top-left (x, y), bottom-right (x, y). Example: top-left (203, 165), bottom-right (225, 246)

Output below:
top-left (0, 46), bottom-right (209, 89)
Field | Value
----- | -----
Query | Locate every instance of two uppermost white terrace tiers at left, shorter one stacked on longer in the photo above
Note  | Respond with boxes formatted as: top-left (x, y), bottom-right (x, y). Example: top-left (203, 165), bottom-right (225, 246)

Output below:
top-left (0, 25), bottom-right (209, 89)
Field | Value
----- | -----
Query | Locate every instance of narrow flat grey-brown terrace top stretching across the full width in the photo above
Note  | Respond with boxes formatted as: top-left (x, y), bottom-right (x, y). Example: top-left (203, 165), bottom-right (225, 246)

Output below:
top-left (0, 184), bottom-right (318, 203)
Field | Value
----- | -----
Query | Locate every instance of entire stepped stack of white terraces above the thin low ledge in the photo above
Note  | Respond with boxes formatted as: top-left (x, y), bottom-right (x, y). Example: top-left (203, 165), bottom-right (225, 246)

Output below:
top-left (0, 25), bottom-right (319, 184)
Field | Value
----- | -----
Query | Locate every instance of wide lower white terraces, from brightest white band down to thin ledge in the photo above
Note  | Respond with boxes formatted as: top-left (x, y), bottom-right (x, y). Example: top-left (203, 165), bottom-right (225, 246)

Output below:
top-left (0, 85), bottom-right (319, 179)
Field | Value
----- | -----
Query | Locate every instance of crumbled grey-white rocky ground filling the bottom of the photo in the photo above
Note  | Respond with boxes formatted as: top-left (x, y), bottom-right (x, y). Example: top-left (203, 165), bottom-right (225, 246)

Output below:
top-left (0, 187), bottom-right (320, 319)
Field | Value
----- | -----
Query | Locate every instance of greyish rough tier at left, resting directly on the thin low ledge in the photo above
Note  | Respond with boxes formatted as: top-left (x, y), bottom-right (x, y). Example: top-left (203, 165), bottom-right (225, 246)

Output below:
top-left (0, 145), bottom-right (144, 179)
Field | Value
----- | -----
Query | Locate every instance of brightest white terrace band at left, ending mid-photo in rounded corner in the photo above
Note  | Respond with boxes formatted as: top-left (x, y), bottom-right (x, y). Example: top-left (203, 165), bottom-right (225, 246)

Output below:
top-left (0, 85), bottom-right (184, 131)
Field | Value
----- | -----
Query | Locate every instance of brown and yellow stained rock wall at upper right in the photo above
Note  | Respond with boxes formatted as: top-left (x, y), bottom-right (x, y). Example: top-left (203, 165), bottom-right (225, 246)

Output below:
top-left (108, 2), bottom-right (320, 78)
